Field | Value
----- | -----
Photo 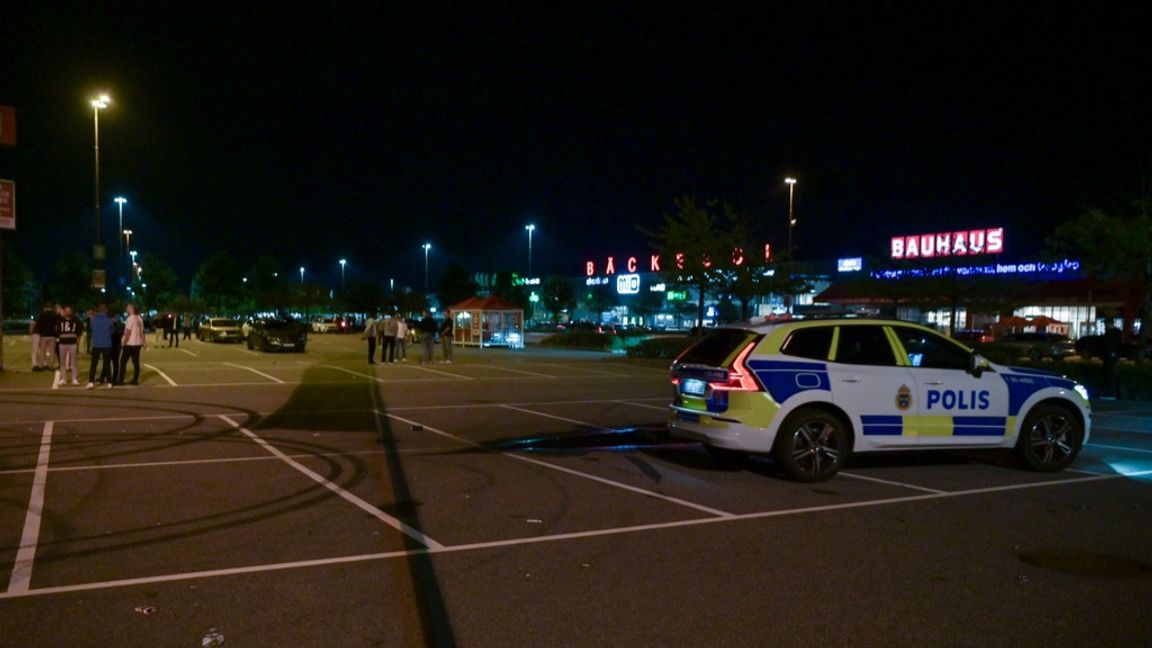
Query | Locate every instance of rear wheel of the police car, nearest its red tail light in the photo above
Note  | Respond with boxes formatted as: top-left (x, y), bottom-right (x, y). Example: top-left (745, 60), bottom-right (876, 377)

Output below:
top-left (773, 408), bottom-right (849, 482)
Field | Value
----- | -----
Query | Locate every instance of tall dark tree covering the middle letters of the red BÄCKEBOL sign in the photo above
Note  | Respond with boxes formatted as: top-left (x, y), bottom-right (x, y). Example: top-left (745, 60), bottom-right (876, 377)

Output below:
top-left (642, 196), bottom-right (737, 326)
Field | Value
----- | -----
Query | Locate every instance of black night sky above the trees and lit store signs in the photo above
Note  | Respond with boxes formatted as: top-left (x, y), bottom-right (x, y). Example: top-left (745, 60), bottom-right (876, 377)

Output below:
top-left (0, 1), bottom-right (1152, 289)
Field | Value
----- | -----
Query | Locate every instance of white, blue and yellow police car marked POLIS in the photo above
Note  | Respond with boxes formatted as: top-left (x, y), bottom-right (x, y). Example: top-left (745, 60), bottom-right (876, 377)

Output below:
top-left (668, 319), bottom-right (1092, 482)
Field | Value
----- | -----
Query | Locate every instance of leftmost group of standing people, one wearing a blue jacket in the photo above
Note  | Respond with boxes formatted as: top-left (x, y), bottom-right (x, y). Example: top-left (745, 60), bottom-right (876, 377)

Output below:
top-left (29, 303), bottom-right (144, 390)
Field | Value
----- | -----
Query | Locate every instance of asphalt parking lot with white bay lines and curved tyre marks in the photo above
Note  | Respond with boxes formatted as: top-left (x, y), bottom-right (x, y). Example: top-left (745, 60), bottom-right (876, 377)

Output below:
top-left (0, 336), bottom-right (1152, 646)
